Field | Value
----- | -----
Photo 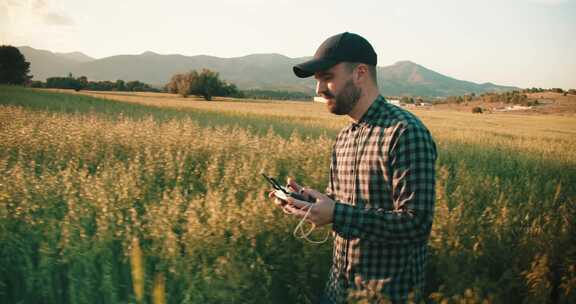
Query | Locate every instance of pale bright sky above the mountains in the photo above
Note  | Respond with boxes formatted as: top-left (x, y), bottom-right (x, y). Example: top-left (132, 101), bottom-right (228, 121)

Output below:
top-left (0, 0), bottom-right (576, 89)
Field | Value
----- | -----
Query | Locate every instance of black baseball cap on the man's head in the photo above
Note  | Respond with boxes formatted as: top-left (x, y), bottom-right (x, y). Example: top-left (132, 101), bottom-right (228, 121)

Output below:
top-left (292, 32), bottom-right (378, 78)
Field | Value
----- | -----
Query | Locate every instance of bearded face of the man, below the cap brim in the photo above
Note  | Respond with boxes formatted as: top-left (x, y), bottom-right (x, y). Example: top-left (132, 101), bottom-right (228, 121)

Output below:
top-left (314, 63), bottom-right (362, 115)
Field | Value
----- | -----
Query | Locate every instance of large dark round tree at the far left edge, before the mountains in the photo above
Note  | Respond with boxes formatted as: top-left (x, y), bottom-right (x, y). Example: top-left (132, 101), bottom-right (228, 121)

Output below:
top-left (0, 45), bottom-right (32, 85)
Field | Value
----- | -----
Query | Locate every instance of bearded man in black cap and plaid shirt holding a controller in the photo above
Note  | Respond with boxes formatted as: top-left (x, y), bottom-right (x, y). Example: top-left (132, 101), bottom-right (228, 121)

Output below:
top-left (276, 32), bottom-right (436, 303)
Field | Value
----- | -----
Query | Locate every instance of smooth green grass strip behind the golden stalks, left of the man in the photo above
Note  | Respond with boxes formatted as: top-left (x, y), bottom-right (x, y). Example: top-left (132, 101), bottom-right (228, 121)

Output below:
top-left (0, 86), bottom-right (343, 138)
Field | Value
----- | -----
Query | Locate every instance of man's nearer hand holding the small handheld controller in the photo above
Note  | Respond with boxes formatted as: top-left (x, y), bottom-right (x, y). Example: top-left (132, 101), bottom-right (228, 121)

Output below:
top-left (283, 188), bottom-right (336, 226)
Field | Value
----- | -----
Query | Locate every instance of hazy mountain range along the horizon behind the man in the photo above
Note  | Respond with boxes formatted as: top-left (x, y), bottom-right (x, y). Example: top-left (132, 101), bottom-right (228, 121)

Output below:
top-left (19, 46), bottom-right (517, 96)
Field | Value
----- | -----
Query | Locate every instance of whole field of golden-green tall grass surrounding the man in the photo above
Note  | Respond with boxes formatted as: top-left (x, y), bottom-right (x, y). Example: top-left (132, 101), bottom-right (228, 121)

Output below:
top-left (0, 86), bottom-right (576, 303)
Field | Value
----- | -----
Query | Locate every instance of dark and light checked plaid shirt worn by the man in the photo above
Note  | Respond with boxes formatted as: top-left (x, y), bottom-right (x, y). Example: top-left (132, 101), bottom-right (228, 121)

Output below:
top-left (326, 96), bottom-right (436, 303)
